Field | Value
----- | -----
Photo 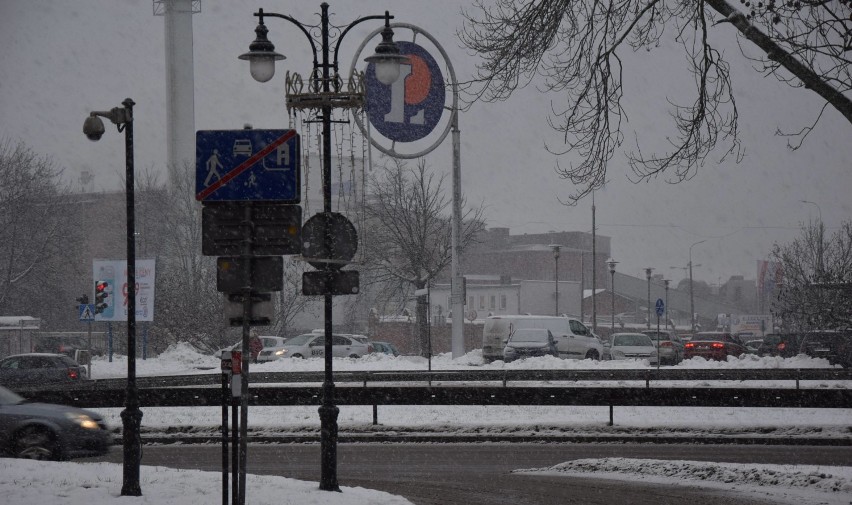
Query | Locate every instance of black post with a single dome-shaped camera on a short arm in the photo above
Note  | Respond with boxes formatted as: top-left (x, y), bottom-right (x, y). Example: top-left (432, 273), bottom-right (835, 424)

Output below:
top-left (83, 98), bottom-right (142, 496)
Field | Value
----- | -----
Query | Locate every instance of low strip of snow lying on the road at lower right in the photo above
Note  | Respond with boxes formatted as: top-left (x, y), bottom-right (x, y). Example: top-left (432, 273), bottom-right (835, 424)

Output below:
top-left (514, 458), bottom-right (852, 503)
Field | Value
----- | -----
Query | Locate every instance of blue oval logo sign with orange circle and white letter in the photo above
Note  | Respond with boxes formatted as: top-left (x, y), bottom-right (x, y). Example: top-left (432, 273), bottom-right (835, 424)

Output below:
top-left (366, 41), bottom-right (446, 142)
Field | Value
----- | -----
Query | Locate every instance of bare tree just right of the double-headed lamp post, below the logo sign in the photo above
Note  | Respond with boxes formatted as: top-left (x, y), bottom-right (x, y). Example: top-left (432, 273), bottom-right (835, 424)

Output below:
top-left (363, 159), bottom-right (484, 356)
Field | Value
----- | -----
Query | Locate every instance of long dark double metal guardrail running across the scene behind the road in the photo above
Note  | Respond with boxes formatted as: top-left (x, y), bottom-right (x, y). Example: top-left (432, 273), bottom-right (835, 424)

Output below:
top-left (8, 368), bottom-right (852, 410)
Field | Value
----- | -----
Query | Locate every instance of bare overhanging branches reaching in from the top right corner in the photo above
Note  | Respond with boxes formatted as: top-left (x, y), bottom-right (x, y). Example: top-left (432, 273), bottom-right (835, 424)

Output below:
top-left (459, 0), bottom-right (852, 202)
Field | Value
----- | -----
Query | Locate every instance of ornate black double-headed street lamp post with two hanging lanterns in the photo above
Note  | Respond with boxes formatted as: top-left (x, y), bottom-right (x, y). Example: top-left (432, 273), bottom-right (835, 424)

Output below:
top-left (240, 2), bottom-right (408, 492)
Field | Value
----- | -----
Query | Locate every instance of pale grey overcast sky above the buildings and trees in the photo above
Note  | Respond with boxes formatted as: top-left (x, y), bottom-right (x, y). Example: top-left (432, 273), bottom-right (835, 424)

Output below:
top-left (0, 0), bottom-right (852, 284)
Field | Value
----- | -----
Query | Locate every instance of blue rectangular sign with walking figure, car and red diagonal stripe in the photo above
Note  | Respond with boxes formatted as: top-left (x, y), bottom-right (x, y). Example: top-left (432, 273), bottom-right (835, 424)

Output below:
top-left (195, 129), bottom-right (301, 203)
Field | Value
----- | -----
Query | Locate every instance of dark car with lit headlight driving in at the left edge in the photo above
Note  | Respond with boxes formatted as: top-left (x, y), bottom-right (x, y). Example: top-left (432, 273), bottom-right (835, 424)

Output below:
top-left (0, 386), bottom-right (113, 460)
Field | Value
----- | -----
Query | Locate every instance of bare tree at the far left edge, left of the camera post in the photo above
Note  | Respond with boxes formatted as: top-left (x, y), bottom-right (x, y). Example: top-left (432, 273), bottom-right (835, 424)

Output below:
top-left (0, 140), bottom-right (81, 319)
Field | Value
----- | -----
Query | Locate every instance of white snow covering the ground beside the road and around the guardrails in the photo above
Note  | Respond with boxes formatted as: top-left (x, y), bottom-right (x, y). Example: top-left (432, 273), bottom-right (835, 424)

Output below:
top-left (0, 345), bottom-right (852, 505)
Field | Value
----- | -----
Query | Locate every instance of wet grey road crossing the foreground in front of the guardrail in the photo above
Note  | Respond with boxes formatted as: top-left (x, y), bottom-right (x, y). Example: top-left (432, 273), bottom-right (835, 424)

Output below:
top-left (81, 444), bottom-right (852, 505)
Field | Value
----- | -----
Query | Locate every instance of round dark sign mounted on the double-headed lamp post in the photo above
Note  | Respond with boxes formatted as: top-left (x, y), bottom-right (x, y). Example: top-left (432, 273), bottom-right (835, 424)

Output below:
top-left (302, 212), bottom-right (358, 270)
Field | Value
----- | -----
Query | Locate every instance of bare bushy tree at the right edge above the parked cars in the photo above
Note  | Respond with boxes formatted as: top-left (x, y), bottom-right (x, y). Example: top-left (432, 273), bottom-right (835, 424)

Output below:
top-left (772, 221), bottom-right (852, 331)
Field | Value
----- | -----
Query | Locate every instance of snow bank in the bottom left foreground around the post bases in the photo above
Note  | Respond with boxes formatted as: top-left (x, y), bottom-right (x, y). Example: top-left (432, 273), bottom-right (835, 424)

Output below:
top-left (0, 459), bottom-right (411, 505)
